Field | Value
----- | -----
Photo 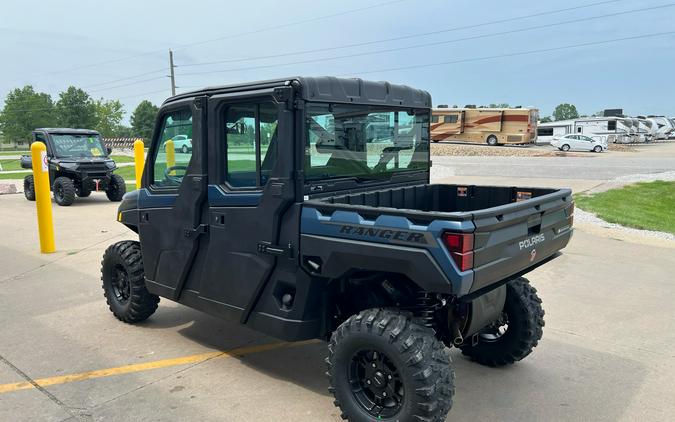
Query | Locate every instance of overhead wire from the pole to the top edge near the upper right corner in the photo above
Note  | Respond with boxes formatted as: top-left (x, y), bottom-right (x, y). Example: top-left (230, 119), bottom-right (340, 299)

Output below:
top-left (179, 0), bottom-right (624, 67)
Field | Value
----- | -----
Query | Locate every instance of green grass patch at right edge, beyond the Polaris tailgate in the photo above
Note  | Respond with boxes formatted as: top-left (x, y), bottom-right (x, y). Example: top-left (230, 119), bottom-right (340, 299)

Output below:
top-left (574, 181), bottom-right (675, 234)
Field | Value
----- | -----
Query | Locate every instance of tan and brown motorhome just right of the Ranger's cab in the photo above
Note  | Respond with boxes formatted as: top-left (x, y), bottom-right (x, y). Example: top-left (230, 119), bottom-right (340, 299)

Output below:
top-left (431, 106), bottom-right (539, 146)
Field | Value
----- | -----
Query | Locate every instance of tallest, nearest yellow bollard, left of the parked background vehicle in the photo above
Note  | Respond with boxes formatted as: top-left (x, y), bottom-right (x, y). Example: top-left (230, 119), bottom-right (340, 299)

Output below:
top-left (30, 142), bottom-right (56, 253)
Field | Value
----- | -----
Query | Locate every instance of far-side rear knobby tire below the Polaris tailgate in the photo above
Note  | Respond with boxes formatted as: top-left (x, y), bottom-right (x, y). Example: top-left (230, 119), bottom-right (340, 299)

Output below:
top-left (460, 277), bottom-right (544, 366)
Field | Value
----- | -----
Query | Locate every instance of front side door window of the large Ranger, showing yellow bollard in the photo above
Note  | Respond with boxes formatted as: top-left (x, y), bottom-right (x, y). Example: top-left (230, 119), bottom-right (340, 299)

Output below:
top-left (152, 109), bottom-right (192, 187)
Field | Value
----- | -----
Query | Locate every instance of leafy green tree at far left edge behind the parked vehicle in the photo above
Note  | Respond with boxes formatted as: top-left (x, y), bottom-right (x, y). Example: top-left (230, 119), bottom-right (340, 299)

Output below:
top-left (0, 85), bottom-right (55, 141)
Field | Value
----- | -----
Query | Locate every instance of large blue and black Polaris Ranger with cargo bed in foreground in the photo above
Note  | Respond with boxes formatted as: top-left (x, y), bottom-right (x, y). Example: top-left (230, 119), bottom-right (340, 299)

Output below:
top-left (102, 77), bottom-right (574, 421)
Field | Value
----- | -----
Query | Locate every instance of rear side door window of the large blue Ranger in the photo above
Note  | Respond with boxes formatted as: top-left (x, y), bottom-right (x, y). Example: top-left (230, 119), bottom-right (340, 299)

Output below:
top-left (225, 102), bottom-right (279, 188)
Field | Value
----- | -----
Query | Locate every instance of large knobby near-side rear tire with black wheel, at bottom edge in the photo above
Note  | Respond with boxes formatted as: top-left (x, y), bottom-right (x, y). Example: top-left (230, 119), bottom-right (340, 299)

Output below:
top-left (326, 309), bottom-right (455, 422)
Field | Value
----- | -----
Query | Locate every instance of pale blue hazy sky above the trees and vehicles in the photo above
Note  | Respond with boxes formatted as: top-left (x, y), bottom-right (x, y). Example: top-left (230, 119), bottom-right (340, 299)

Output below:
top-left (0, 0), bottom-right (675, 121)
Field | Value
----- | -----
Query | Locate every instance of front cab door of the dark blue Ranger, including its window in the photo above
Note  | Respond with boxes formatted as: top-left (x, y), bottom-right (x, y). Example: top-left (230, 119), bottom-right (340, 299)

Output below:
top-left (138, 97), bottom-right (207, 300)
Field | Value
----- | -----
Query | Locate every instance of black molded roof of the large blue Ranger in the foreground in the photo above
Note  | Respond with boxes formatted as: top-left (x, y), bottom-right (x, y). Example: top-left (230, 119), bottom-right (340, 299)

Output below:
top-left (164, 76), bottom-right (431, 108)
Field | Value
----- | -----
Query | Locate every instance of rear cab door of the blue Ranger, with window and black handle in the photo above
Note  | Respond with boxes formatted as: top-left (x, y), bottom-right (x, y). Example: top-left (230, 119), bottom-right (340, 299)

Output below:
top-left (193, 87), bottom-right (297, 323)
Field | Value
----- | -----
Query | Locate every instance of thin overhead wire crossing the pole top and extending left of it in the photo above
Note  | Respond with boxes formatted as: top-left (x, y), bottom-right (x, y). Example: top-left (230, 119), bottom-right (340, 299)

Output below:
top-left (30, 0), bottom-right (407, 76)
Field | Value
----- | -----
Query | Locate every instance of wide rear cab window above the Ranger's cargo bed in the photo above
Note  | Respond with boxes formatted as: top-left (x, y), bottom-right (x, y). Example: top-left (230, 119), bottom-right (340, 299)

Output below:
top-left (305, 103), bottom-right (430, 181)
